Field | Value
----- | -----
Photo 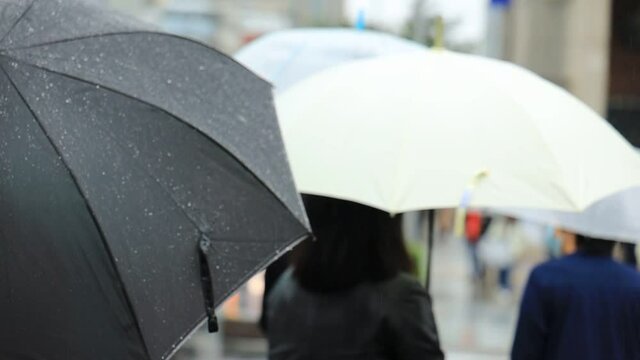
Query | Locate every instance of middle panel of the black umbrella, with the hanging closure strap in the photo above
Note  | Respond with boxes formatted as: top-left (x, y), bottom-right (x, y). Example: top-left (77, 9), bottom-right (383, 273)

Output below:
top-left (0, 61), bottom-right (305, 358)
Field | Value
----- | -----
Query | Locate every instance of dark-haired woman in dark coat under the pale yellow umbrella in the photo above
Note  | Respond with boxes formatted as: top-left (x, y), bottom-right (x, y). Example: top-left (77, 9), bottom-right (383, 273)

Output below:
top-left (267, 196), bottom-right (444, 360)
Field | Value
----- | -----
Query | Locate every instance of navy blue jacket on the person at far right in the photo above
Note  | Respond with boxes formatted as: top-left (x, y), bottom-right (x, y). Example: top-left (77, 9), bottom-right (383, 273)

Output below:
top-left (511, 253), bottom-right (640, 360)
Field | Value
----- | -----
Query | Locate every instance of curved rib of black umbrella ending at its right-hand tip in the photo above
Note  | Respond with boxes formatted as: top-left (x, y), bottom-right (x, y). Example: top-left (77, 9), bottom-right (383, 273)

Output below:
top-left (3, 54), bottom-right (307, 229)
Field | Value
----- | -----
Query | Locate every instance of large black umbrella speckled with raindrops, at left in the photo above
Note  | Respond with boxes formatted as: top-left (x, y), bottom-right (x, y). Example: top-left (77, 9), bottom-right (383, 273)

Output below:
top-left (0, 0), bottom-right (308, 360)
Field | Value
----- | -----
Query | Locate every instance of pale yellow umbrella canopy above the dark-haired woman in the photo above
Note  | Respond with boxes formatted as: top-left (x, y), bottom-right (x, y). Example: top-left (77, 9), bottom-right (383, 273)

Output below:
top-left (276, 50), bottom-right (640, 213)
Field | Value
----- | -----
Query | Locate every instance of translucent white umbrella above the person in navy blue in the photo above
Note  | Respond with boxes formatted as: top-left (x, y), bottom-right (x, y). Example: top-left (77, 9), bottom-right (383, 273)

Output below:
top-left (492, 187), bottom-right (640, 243)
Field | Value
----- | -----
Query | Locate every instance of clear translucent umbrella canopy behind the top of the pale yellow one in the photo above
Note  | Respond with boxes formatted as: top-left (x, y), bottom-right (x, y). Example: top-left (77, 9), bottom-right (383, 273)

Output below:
top-left (235, 28), bottom-right (424, 92)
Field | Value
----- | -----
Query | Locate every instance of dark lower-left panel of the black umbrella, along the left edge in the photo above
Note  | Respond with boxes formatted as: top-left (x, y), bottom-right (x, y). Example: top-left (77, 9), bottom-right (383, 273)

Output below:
top-left (0, 65), bottom-right (148, 360)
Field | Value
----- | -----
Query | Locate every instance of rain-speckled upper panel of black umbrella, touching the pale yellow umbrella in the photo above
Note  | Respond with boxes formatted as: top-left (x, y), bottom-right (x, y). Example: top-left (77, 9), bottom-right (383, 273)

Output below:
top-left (4, 32), bottom-right (306, 222)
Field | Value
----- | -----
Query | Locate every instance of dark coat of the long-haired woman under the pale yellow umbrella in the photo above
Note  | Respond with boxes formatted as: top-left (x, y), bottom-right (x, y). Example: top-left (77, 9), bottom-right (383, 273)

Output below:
top-left (267, 270), bottom-right (444, 360)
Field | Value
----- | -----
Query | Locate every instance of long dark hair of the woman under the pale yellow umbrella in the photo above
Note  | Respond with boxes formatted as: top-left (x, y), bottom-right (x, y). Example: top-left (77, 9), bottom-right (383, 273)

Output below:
top-left (293, 195), bottom-right (411, 292)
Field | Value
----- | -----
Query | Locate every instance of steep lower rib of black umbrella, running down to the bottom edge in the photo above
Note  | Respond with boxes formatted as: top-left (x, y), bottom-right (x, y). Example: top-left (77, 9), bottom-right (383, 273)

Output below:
top-left (0, 65), bottom-right (151, 359)
